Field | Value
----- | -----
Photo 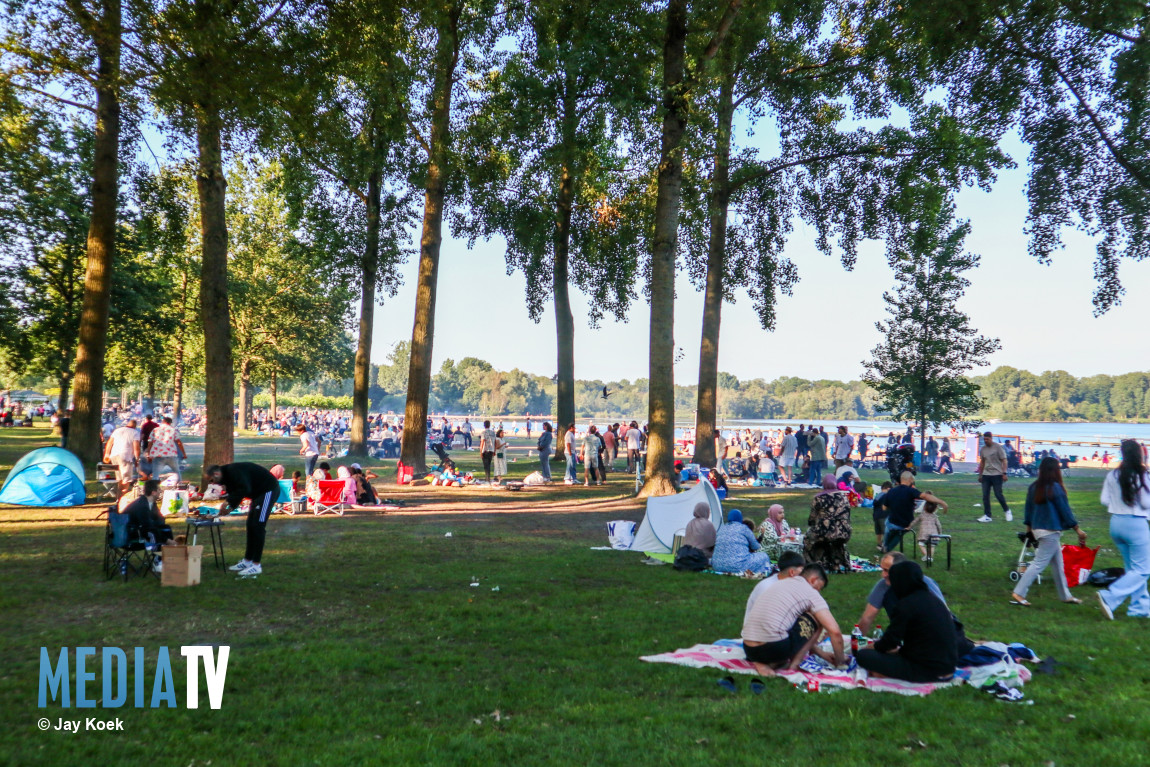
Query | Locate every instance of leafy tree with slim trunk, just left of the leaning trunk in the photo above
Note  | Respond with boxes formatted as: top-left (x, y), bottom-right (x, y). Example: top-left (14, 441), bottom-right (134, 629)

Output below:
top-left (268, 0), bottom-right (413, 455)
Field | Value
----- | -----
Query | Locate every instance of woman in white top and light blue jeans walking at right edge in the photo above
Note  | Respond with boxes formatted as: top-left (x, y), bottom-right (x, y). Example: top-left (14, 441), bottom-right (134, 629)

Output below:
top-left (1098, 439), bottom-right (1150, 620)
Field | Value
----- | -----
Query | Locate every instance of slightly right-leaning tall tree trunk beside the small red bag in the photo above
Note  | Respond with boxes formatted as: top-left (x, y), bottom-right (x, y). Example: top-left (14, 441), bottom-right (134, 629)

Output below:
top-left (401, 5), bottom-right (460, 473)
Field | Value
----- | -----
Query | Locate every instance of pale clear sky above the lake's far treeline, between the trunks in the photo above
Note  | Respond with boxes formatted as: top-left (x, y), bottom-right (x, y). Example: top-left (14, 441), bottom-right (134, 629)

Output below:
top-left (373, 130), bottom-right (1150, 384)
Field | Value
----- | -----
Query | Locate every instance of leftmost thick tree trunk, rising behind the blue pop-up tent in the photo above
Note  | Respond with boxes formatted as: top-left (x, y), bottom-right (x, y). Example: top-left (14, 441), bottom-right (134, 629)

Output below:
top-left (62, 0), bottom-right (122, 466)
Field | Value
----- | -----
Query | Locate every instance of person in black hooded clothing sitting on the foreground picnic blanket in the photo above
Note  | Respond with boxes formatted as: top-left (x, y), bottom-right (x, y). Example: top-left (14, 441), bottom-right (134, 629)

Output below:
top-left (858, 562), bottom-right (958, 682)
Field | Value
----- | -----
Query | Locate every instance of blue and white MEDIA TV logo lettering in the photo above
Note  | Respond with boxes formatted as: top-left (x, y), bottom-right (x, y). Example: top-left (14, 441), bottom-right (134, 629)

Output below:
top-left (38, 645), bottom-right (231, 708)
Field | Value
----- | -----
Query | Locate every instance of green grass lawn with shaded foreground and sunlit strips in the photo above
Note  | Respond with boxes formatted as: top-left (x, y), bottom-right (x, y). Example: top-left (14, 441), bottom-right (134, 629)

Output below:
top-left (0, 429), bottom-right (1150, 767)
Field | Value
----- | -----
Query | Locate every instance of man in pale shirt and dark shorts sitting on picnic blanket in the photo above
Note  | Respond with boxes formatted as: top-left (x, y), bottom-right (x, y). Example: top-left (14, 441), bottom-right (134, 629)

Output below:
top-left (740, 563), bottom-right (846, 676)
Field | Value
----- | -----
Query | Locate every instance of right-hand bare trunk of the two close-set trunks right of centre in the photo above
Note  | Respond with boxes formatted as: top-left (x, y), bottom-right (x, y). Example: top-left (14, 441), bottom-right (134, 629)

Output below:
top-left (695, 56), bottom-right (735, 468)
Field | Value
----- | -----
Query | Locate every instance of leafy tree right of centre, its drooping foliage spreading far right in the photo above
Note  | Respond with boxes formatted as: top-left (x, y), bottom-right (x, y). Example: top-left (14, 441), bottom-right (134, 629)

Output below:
top-left (684, 2), bottom-right (1010, 466)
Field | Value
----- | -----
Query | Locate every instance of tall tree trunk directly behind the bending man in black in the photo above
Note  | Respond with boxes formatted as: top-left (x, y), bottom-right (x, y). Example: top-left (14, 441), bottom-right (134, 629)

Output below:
top-left (196, 103), bottom-right (236, 467)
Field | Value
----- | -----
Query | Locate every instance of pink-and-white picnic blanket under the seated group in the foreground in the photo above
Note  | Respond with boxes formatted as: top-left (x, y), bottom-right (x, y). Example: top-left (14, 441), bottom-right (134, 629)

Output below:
top-left (639, 639), bottom-right (1030, 696)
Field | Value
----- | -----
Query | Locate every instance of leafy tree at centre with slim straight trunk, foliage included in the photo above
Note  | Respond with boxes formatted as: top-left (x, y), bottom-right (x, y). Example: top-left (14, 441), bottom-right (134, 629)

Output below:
top-left (459, 0), bottom-right (656, 459)
